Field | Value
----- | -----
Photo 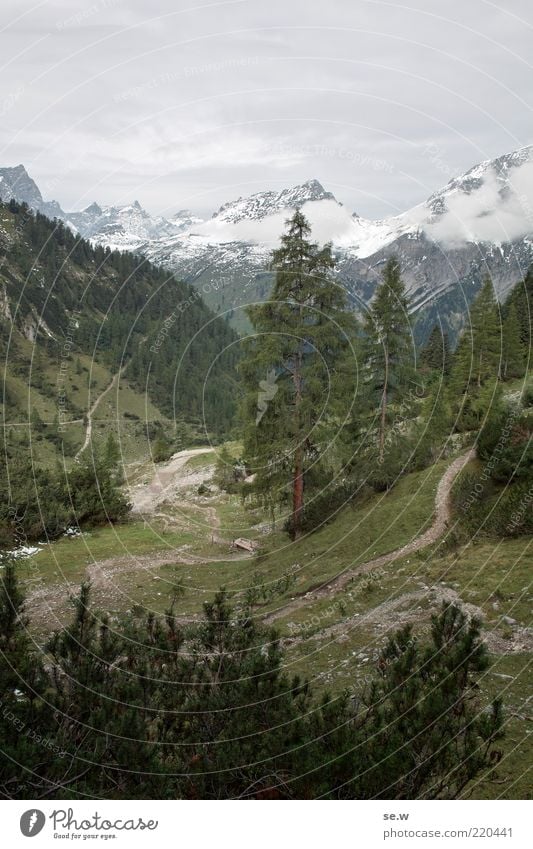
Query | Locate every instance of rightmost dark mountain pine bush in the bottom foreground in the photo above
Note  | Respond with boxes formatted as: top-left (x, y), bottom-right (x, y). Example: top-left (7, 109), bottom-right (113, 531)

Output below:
top-left (344, 604), bottom-right (503, 799)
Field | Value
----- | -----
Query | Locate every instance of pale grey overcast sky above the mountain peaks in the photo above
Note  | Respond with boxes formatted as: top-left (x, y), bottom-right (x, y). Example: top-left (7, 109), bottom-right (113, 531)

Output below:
top-left (0, 0), bottom-right (533, 218)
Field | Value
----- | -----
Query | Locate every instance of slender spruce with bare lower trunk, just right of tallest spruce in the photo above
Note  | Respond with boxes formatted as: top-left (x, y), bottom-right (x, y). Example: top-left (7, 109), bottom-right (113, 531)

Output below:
top-left (365, 258), bottom-right (413, 462)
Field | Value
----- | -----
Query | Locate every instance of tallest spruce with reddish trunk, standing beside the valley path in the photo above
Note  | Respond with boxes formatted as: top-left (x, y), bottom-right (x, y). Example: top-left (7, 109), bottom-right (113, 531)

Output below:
top-left (241, 210), bottom-right (355, 538)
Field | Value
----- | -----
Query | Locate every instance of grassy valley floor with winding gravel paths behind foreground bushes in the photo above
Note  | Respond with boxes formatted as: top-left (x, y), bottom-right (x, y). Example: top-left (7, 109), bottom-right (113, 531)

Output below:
top-left (14, 448), bottom-right (533, 798)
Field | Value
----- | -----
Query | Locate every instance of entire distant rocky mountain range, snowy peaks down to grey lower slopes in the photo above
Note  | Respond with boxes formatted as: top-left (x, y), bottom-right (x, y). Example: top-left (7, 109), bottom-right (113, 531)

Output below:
top-left (4, 146), bottom-right (533, 333)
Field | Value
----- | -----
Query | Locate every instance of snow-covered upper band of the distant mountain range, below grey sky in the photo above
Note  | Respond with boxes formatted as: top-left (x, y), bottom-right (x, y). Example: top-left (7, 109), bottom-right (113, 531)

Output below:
top-left (6, 146), bottom-right (533, 261)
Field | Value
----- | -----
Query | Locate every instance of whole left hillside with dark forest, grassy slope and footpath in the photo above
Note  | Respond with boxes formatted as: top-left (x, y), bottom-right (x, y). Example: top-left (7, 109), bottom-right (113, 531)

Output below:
top-left (0, 200), bottom-right (236, 545)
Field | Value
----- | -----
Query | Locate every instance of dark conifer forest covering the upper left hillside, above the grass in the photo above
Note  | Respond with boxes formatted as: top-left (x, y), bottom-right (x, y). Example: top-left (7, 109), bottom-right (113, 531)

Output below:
top-left (0, 201), bottom-right (235, 433)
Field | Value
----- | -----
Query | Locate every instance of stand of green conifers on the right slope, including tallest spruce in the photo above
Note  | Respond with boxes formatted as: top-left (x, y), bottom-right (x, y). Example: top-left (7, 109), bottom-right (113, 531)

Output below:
top-left (240, 212), bottom-right (533, 537)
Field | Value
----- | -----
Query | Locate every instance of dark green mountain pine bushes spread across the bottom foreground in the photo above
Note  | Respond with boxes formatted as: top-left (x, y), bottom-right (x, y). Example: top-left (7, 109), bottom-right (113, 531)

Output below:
top-left (0, 561), bottom-right (502, 799)
